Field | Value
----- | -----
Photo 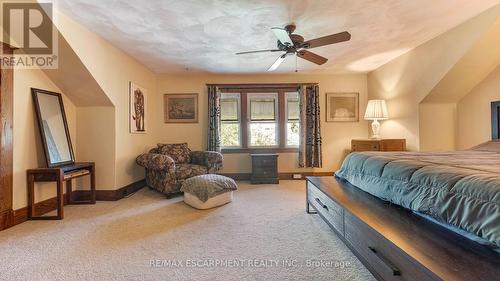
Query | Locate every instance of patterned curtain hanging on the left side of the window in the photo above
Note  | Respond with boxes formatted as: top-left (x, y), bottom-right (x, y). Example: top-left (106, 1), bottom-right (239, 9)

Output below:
top-left (207, 86), bottom-right (220, 152)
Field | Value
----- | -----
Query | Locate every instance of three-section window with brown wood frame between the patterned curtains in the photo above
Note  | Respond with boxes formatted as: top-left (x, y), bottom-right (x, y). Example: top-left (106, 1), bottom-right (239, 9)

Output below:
top-left (221, 87), bottom-right (300, 153)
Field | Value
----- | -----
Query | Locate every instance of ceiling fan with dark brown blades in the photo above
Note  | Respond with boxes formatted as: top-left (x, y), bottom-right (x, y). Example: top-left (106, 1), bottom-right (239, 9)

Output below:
top-left (236, 24), bottom-right (351, 71)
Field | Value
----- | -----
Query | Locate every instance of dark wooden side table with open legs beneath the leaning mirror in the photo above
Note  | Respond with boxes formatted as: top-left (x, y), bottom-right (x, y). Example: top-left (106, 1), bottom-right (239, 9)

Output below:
top-left (27, 162), bottom-right (96, 220)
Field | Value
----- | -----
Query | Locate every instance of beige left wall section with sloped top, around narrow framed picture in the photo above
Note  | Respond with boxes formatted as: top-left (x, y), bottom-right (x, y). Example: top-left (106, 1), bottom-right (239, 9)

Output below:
top-left (55, 13), bottom-right (161, 189)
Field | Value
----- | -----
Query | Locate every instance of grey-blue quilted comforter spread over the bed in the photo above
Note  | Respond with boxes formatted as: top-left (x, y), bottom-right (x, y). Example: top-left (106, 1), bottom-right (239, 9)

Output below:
top-left (336, 140), bottom-right (500, 248)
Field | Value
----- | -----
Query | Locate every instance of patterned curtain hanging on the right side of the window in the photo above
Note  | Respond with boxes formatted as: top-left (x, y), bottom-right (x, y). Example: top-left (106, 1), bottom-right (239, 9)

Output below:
top-left (299, 85), bottom-right (323, 168)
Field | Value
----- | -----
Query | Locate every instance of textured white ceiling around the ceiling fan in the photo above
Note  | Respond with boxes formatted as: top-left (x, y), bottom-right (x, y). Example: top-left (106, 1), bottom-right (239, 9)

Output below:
top-left (57, 0), bottom-right (500, 73)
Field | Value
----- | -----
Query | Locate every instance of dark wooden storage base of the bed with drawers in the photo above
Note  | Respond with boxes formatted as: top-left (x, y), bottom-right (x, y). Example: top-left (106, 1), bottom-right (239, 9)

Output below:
top-left (306, 177), bottom-right (500, 281)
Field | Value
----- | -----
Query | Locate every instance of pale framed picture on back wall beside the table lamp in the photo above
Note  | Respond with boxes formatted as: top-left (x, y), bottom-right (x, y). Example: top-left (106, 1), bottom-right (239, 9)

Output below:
top-left (326, 93), bottom-right (359, 122)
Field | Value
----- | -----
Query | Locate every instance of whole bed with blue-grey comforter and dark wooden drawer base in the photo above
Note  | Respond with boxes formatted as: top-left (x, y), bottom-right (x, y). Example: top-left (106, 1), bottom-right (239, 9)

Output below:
top-left (306, 102), bottom-right (500, 281)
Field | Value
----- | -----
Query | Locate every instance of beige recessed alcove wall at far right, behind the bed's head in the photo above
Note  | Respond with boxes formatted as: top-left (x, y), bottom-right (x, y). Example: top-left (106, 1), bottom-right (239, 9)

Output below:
top-left (457, 64), bottom-right (500, 149)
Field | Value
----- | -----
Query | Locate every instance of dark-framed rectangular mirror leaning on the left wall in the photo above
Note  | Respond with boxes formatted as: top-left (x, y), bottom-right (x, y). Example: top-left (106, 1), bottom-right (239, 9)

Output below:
top-left (31, 88), bottom-right (75, 168)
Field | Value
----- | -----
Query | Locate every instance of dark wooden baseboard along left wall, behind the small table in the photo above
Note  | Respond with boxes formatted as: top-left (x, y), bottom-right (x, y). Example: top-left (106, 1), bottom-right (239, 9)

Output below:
top-left (0, 179), bottom-right (146, 230)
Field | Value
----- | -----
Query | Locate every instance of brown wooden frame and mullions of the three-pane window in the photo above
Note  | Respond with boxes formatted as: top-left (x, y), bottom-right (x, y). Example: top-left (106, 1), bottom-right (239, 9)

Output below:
top-left (219, 84), bottom-right (300, 153)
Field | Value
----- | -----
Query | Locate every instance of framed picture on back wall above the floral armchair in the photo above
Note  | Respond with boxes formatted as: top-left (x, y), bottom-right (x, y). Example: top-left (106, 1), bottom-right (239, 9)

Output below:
top-left (163, 94), bottom-right (198, 123)
